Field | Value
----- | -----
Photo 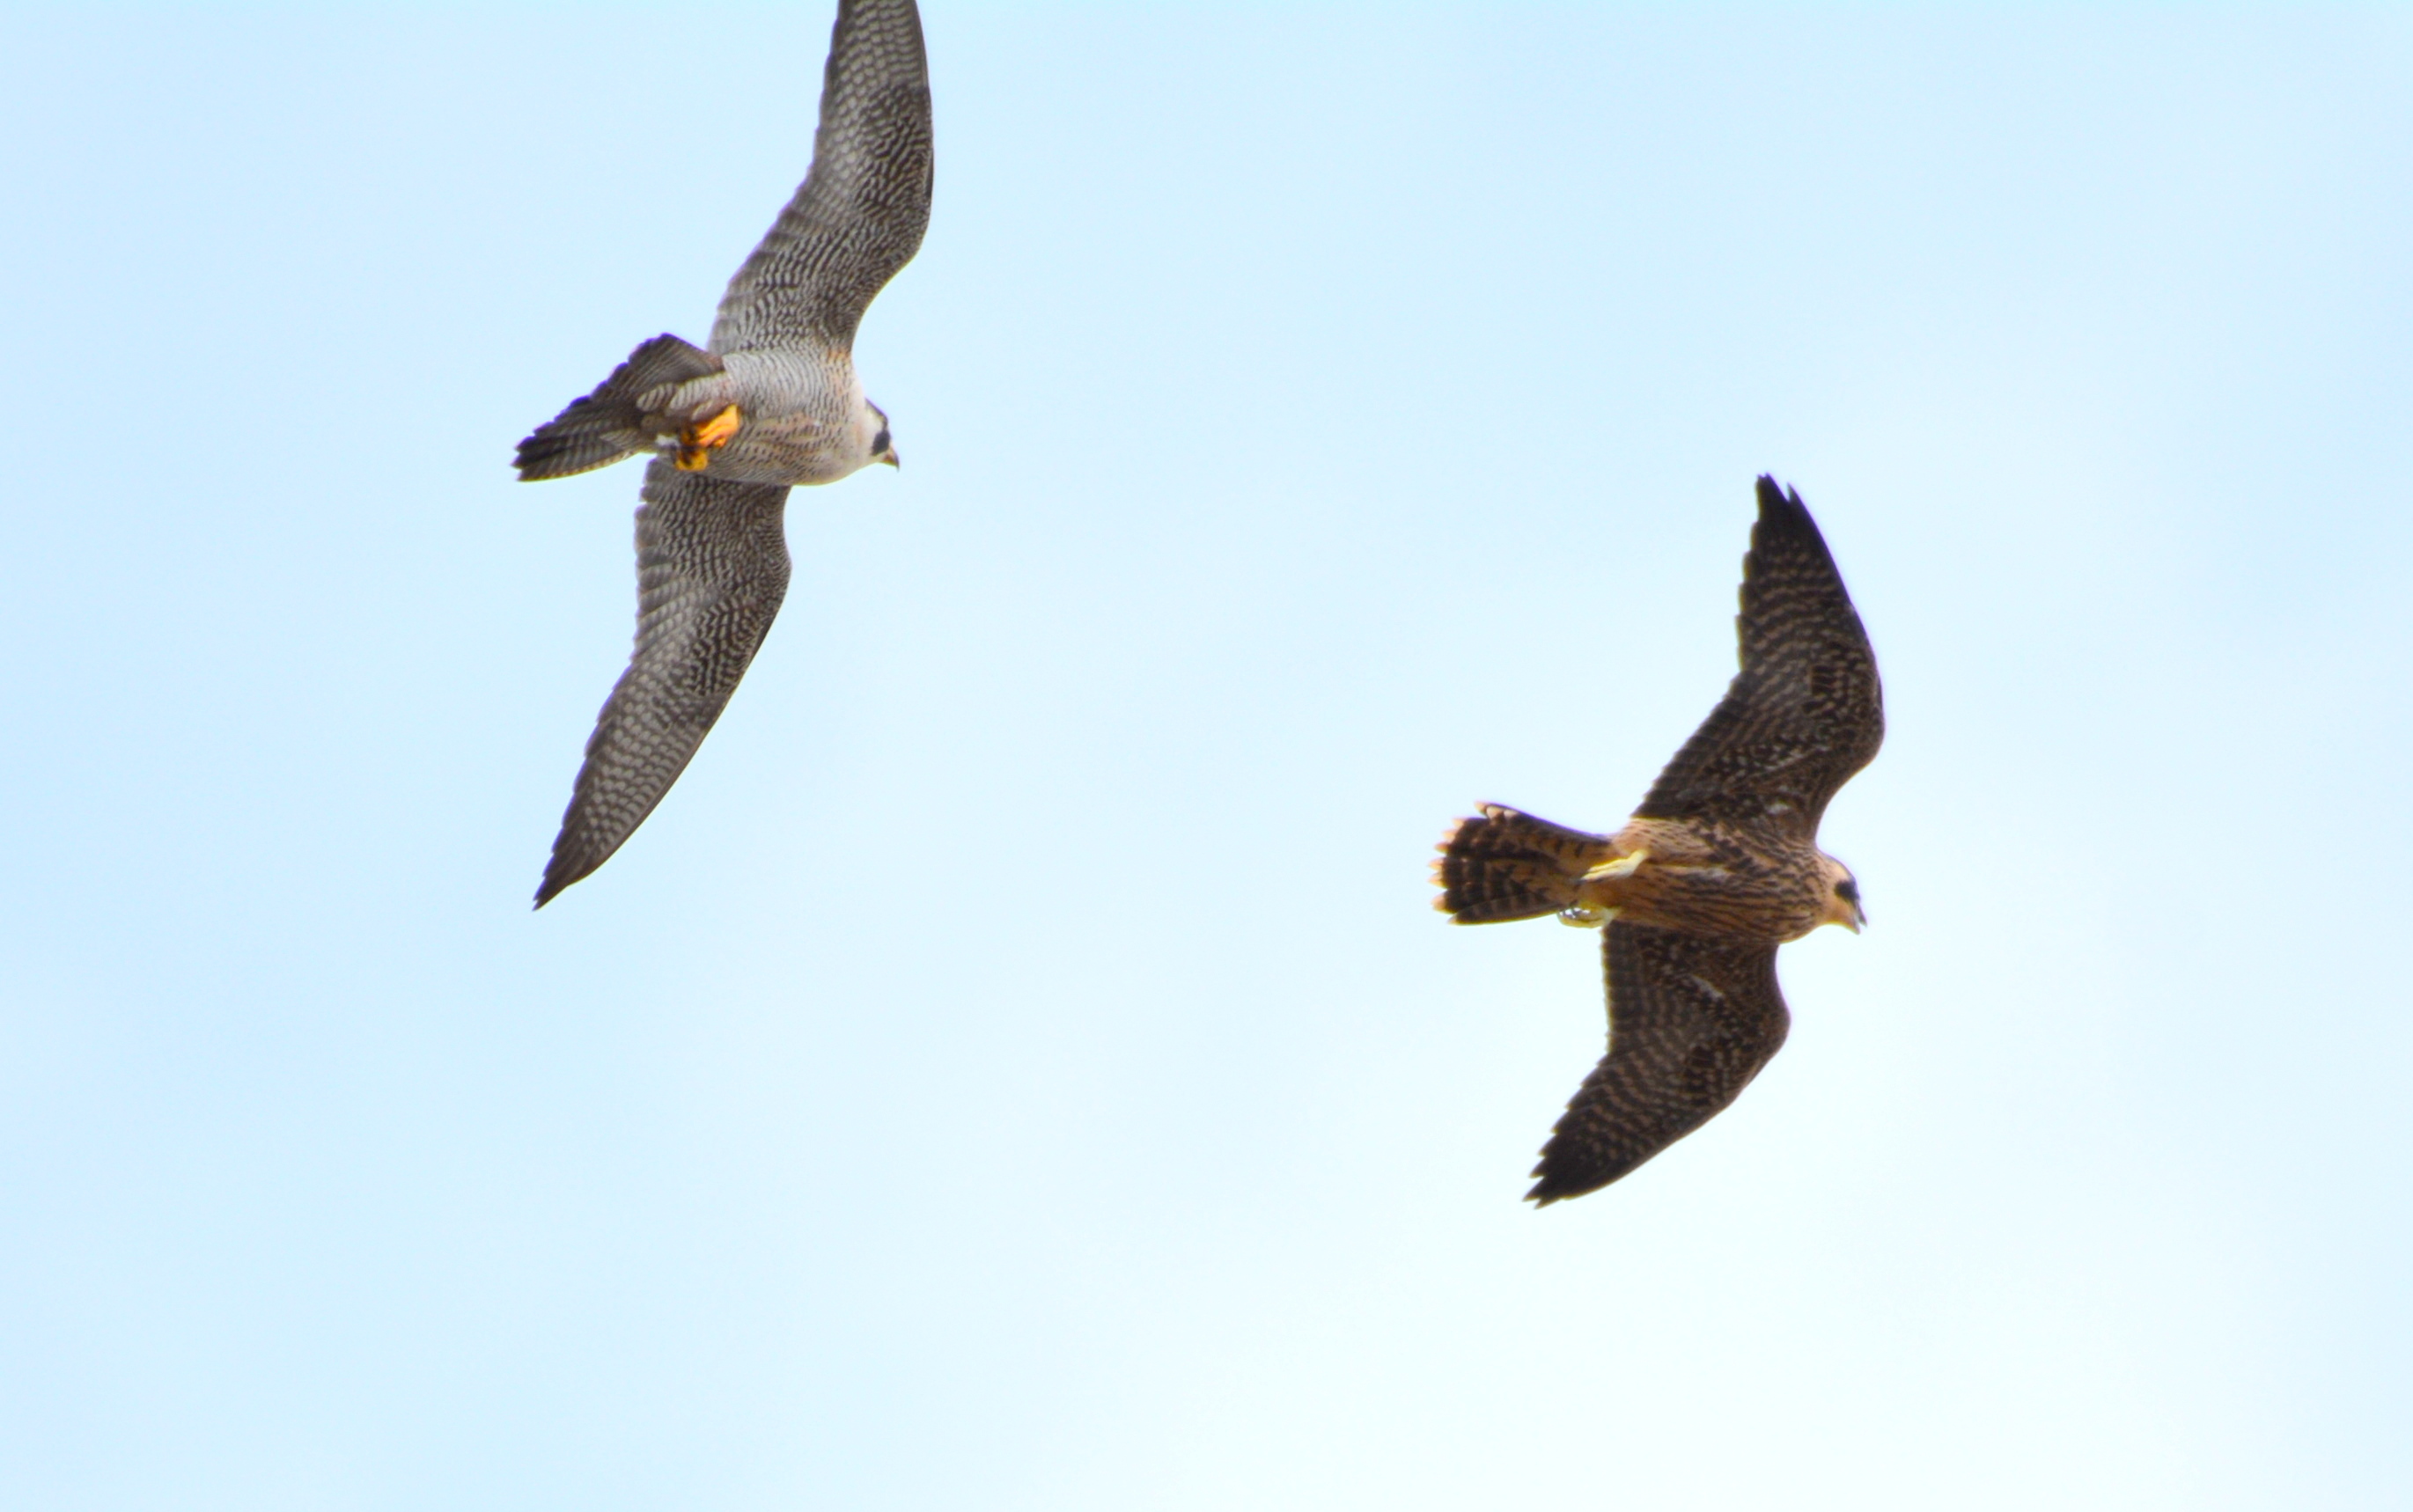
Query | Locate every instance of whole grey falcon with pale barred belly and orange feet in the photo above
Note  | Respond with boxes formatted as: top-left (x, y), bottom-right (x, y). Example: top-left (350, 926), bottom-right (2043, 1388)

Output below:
top-left (517, 0), bottom-right (931, 906)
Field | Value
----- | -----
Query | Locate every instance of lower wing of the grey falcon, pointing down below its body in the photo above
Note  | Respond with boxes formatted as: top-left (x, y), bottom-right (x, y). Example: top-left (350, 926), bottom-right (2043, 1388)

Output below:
top-left (536, 459), bottom-right (787, 906)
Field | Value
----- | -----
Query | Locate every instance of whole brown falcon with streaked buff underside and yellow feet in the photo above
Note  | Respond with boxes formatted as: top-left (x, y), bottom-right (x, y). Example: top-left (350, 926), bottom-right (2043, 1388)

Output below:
top-left (1433, 478), bottom-right (1885, 1206)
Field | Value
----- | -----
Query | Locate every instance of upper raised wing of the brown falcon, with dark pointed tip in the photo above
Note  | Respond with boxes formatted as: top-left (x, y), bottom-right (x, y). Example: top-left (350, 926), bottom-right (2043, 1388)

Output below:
top-left (1634, 478), bottom-right (1885, 840)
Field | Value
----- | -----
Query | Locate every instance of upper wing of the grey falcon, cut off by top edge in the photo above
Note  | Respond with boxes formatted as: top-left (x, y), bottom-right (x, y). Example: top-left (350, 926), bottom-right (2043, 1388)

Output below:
top-left (712, 0), bottom-right (931, 352)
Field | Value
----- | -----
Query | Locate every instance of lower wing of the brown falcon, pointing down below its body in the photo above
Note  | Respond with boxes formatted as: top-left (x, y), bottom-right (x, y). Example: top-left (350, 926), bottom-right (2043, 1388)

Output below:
top-left (1525, 921), bottom-right (1791, 1206)
